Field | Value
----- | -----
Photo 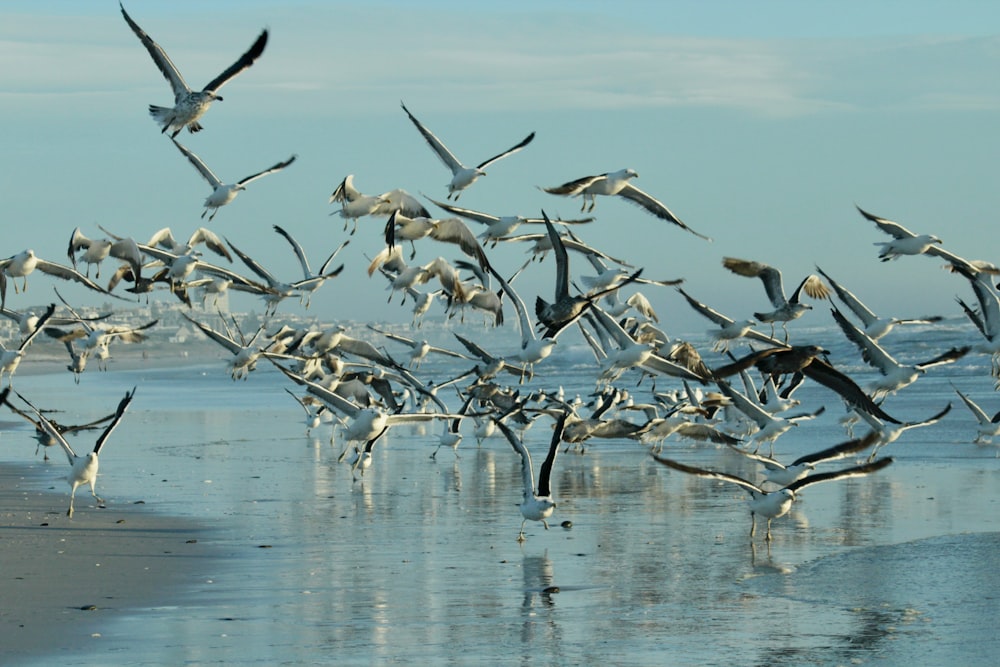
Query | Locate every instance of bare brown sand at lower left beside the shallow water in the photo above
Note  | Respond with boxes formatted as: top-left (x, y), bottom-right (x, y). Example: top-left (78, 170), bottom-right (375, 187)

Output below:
top-left (0, 463), bottom-right (215, 664)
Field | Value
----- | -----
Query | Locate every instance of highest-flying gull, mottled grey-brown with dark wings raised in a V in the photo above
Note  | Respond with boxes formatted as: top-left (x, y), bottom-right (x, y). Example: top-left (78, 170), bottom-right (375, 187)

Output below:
top-left (118, 2), bottom-right (267, 137)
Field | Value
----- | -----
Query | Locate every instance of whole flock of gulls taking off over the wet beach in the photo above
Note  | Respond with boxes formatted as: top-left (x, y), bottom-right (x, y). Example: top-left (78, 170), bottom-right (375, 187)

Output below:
top-left (0, 6), bottom-right (1000, 543)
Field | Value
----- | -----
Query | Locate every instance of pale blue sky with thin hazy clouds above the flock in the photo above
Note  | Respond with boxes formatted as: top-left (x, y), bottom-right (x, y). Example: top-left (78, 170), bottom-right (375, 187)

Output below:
top-left (0, 0), bottom-right (1000, 335)
